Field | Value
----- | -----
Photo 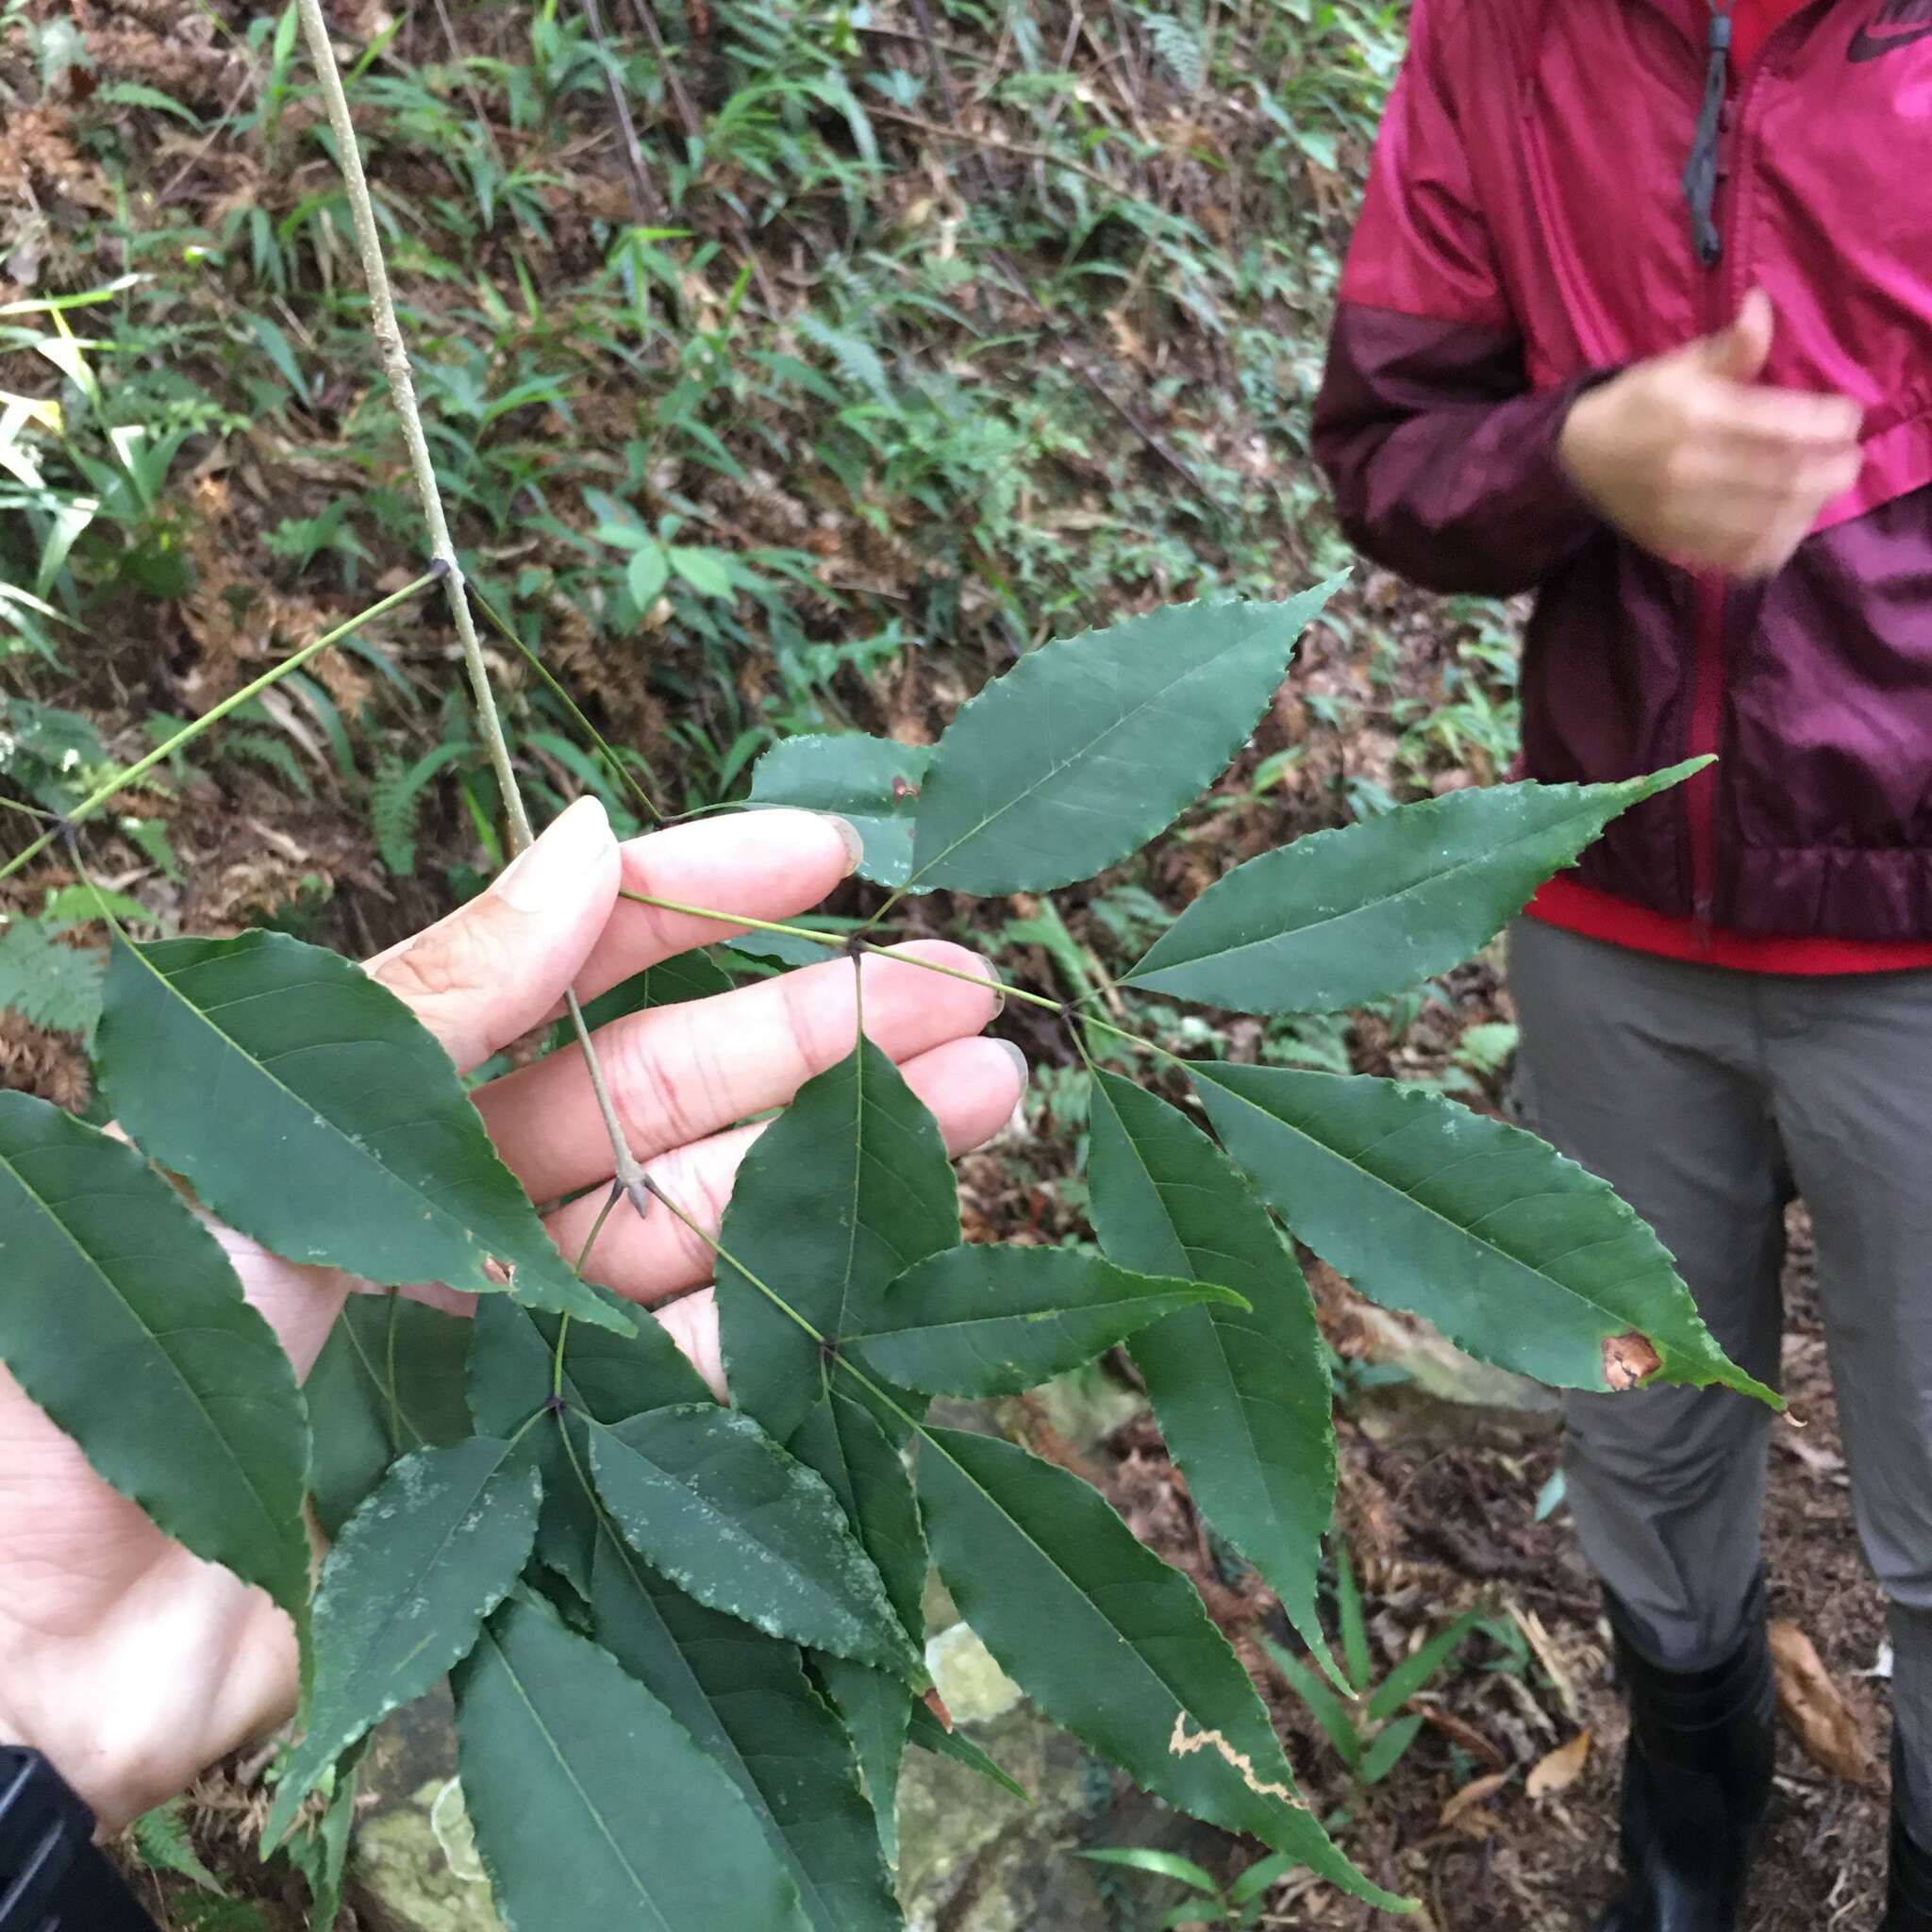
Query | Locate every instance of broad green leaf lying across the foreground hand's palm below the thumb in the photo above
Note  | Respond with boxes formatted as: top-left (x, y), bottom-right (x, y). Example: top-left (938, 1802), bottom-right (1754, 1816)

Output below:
top-left (98, 931), bottom-right (628, 1325)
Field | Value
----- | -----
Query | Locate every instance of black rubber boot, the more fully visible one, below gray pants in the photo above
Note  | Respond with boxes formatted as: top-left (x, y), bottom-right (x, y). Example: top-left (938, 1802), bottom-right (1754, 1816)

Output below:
top-left (1598, 1586), bottom-right (1769, 1932)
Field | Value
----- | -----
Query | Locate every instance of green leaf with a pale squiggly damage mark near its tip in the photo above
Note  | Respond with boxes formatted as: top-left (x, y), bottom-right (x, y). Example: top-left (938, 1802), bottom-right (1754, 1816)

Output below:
top-left (920, 1430), bottom-right (1405, 1908)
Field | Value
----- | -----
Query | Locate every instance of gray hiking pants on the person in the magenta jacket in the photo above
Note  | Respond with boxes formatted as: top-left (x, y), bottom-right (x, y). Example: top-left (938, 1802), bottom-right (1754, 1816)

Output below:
top-left (1508, 920), bottom-right (1932, 1845)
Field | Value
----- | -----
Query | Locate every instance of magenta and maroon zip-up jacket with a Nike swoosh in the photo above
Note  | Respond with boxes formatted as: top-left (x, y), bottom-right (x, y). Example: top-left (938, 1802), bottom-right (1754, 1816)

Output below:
top-left (1314, 0), bottom-right (1932, 941)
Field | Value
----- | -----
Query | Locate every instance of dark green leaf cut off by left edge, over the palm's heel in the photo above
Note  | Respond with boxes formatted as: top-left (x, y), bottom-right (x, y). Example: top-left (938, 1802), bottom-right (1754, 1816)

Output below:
top-left (0, 1093), bottom-right (309, 1624)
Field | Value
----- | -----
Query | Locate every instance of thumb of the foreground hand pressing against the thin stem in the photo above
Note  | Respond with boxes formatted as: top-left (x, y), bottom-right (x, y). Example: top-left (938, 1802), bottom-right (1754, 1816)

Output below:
top-left (365, 798), bottom-right (618, 1073)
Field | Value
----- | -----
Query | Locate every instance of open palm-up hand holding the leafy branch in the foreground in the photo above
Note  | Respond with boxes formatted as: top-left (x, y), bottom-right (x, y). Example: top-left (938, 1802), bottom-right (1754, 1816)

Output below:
top-left (0, 800), bottom-right (1024, 1829)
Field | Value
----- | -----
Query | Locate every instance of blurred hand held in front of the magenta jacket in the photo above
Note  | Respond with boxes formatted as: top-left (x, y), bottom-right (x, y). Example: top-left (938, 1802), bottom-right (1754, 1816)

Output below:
top-left (1557, 290), bottom-right (1860, 577)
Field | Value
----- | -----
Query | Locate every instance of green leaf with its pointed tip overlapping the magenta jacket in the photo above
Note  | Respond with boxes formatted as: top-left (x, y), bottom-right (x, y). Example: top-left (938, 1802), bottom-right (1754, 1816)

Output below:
top-left (1121, 759), bottom-right (1704, 1012)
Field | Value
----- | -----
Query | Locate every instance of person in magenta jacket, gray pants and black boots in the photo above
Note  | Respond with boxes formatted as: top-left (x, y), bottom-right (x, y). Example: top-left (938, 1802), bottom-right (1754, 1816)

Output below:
top-left (1314, 0), bottom-right (1932, 1932)
